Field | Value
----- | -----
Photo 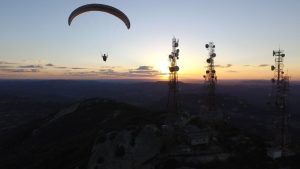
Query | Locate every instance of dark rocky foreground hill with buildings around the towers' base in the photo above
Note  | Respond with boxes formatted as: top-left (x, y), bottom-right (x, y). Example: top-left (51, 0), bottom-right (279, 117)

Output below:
top-left (0, 99), bottom-right (276, 169)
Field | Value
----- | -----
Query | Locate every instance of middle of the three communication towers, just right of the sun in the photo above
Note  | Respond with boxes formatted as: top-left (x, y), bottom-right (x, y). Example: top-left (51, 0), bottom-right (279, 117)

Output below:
top-left (203, 42), bottom-right (217, 111)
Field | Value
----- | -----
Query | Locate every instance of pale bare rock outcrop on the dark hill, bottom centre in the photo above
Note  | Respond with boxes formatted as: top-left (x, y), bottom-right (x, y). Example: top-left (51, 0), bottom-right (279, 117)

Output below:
top-left (88, 125), bottom-right (162, 169)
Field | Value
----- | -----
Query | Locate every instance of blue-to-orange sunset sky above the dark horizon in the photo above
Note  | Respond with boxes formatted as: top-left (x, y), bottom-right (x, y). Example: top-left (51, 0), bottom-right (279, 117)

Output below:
top-left (0, 0), bottom-right (300, 81)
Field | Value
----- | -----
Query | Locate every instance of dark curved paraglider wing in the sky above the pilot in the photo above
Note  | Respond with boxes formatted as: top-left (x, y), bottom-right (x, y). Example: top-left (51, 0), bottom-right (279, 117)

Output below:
top-left (68, 4), bottom-right (130, 29)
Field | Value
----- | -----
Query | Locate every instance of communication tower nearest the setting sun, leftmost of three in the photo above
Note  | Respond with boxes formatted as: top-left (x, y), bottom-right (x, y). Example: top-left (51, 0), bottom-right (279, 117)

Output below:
top-left (167, 37), bottom-right (179, 115)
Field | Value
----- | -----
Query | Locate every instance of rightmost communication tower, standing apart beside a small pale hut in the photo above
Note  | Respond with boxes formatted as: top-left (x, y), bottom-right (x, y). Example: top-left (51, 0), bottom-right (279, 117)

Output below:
top-left (271, 49), bottom-right (290, 157)
